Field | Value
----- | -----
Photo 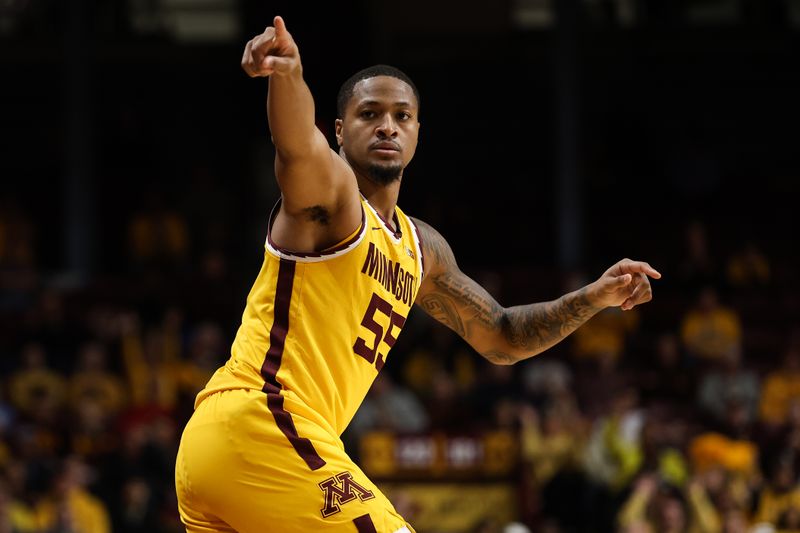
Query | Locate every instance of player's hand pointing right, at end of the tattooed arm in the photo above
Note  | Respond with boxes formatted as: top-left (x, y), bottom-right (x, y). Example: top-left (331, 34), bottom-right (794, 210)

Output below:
top-left (589, 259), bottom-right (661, 311)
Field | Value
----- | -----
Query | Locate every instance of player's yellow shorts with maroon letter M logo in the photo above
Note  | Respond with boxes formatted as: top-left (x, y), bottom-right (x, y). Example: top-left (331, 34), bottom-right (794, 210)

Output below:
top-left (175, 389), bottom-right (413, 533)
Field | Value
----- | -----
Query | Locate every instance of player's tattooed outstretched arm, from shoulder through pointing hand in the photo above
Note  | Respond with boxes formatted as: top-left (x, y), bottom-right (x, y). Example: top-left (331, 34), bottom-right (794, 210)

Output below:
top-left (414, 219), bottom-right (661, 364)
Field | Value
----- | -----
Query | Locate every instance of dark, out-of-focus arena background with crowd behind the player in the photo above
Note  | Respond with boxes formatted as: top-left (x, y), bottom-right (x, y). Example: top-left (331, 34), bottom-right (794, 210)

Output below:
top-left (0, 0), bottom-right (800, 533)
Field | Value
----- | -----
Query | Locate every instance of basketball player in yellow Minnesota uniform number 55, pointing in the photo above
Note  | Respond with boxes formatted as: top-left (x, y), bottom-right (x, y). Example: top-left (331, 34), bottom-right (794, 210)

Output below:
top-left (175, 17), bottom-right (660, 533)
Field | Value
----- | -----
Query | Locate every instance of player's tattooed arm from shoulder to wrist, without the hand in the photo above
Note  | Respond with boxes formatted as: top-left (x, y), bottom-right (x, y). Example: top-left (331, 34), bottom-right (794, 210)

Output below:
top-left (415, 216), bottom-right (599, 364)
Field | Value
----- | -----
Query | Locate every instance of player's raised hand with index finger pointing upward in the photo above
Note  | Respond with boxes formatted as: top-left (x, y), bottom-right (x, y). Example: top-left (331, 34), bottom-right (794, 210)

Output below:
top-left (242, 17), bottom-right (300, 78)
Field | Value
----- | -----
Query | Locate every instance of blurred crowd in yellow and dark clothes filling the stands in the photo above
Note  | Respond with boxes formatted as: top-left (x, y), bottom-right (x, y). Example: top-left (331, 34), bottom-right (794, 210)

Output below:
top-left (0, 188), bottom-right (800, 533)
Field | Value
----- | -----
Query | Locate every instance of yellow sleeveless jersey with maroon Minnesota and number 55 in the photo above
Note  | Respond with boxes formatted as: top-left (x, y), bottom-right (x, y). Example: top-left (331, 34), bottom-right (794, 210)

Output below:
top-left (195, 198), bottom-right (423, 438)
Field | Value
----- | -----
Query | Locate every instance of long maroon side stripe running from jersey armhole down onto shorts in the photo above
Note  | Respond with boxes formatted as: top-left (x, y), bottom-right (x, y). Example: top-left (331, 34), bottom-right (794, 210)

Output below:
top-left (261, 259), bottom-right (325, 470)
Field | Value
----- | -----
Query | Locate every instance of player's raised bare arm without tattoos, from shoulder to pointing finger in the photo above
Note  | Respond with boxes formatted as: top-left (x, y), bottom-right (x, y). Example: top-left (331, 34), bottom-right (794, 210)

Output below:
top-left (242, 17), bottom-right (361, 251)
